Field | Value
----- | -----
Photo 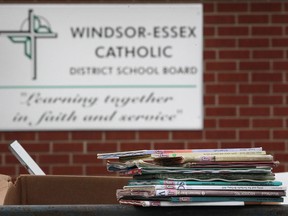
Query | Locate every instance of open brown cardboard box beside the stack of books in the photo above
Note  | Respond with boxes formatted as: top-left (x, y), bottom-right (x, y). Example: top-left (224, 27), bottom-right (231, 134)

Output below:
top-left (0, 175), bottom-right (130, 205)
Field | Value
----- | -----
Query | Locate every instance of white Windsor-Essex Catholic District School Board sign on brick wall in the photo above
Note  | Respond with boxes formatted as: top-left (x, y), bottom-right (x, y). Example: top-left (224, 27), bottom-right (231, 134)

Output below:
top-left (0, 4), bottom-right (203, 131)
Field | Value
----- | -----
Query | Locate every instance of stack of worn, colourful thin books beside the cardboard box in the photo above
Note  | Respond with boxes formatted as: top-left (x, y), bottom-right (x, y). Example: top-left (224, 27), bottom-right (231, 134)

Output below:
top-left (97, 147), bottom-right (286, 206)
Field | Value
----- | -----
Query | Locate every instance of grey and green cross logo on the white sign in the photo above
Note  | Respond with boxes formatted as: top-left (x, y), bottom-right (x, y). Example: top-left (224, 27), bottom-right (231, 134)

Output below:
top-left (0, 9), bottom-right (57, 80)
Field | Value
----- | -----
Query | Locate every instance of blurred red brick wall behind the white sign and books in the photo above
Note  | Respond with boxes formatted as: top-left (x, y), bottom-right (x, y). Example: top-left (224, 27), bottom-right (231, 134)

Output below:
top-left (0, 0), bottom-right (288, 176)
